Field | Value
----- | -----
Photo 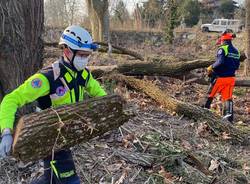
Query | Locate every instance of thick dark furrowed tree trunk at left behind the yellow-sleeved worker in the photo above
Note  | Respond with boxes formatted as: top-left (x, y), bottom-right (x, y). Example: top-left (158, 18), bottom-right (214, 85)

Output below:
top-left (0, 0), bottom-right (44, 101)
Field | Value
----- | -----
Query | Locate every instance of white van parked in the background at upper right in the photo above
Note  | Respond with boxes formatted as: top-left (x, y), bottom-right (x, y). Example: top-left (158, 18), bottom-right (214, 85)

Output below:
top-left (201, 19), bottom-right (243, 32)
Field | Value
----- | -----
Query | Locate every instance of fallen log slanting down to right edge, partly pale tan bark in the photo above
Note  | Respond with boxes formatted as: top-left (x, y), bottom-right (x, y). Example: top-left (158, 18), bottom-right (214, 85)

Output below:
top-left (109, 74), bottom-right (250, 145)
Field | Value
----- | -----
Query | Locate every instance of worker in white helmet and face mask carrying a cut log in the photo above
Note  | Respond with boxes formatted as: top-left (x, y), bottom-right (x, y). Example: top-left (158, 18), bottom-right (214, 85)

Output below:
top-left (0, 26), bottom-right (106, 184)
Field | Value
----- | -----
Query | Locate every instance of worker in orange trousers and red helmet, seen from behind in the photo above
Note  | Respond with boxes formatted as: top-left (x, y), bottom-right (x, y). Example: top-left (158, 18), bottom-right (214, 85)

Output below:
top-left (205, 32), bottom-right (240, 122)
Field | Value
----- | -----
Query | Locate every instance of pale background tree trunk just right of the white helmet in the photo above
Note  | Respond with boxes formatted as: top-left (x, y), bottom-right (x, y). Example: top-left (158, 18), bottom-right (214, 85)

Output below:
top-left (86, 0), bottom-right (109, 42)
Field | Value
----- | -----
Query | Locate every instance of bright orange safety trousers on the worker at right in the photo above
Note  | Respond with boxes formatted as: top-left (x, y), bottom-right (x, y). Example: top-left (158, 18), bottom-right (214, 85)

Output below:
top-left (209, 77), bottom-right (235, 102)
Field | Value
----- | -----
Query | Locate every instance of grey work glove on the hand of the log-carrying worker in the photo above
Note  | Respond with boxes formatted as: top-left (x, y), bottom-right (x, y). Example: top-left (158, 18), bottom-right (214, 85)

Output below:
top-left (0, 129), bottom-right (13, 158)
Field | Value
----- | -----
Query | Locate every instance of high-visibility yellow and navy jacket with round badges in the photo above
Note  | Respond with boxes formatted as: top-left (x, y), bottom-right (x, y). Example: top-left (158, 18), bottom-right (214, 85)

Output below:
top-left (0, 59), bottom-right (106, 131)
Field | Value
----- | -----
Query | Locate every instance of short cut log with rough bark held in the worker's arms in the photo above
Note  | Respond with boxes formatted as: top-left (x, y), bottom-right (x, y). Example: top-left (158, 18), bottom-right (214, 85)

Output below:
top-left (13, 95), bottom-right (130, 162)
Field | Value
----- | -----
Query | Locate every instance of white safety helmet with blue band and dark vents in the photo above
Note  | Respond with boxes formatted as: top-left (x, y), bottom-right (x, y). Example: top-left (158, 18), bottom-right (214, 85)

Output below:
top-left (59, 25), bottom-right (97, 52)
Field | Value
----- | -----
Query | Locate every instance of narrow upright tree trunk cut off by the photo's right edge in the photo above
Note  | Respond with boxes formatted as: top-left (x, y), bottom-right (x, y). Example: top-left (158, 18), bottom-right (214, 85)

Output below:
top-left (244, 0), bottom-right (250, 76)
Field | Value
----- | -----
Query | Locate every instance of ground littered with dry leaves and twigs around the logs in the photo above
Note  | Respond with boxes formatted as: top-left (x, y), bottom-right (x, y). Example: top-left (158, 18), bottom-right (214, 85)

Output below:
top-left (0, 29), bottom-right (250, 184)
